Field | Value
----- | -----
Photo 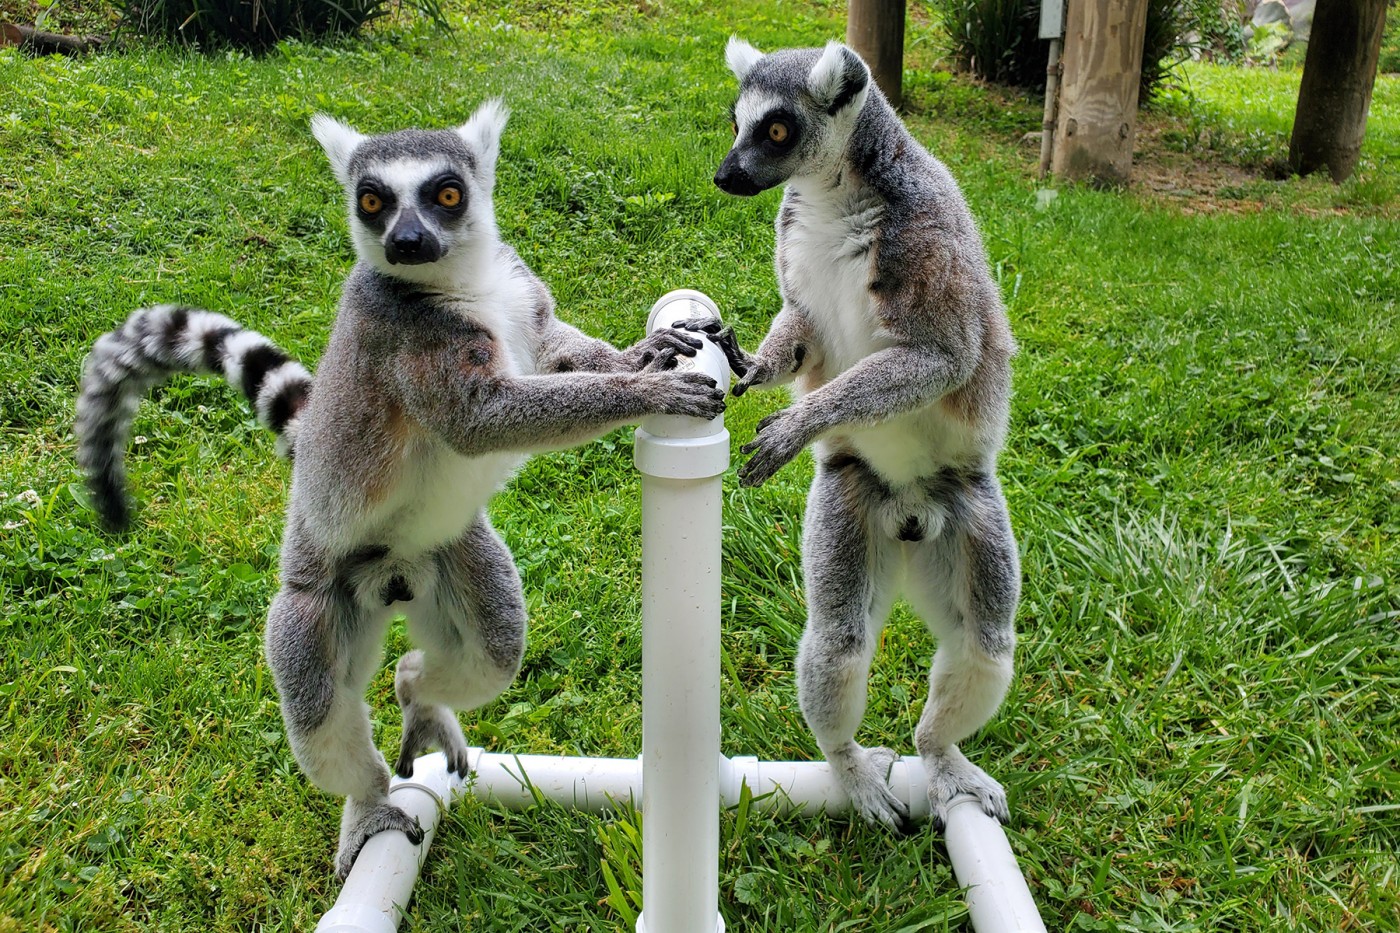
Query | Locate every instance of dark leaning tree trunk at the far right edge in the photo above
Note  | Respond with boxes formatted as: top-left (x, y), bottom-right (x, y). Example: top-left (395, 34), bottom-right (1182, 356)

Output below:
top-left (1288, 0), bottom-right (1386, 184)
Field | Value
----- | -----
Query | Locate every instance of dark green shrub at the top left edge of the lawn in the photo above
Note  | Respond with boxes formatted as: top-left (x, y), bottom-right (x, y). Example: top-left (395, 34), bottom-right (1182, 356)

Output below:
top-left (118, 0), bottom-right (445, 50)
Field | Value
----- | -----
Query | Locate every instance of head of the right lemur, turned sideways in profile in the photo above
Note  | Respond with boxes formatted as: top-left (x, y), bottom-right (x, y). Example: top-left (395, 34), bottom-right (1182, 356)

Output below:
top-left (714, 36), bottom-right (871, 195)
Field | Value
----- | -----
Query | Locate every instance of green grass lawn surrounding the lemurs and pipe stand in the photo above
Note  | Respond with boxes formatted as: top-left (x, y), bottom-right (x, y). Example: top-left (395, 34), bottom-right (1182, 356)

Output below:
top-left (0, 0), bottom-right (1400, 933)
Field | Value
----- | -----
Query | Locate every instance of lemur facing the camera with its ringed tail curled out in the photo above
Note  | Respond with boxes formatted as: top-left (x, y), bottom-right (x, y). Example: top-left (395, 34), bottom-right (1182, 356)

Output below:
top-left (76, 101), bottom-right (724, 877)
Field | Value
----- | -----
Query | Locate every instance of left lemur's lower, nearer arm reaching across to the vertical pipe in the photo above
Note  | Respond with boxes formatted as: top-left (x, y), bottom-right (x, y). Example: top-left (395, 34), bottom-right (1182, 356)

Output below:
top-left (395, 343), bottom-right (724, 457)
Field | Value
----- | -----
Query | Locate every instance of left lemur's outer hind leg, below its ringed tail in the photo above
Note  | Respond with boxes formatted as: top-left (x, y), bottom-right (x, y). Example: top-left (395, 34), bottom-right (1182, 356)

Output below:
top-left (266, 586), bottom-right (423, 880)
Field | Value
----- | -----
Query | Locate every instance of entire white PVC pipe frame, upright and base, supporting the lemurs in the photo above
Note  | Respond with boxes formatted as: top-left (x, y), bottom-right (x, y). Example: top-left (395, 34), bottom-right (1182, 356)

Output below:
top-left (316, 290), bottom-right (1046, 933)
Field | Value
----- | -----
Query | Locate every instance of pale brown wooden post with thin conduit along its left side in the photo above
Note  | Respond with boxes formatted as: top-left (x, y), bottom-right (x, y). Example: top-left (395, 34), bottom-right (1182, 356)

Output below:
top-left (1050, 0), bottom-right (1148, 185)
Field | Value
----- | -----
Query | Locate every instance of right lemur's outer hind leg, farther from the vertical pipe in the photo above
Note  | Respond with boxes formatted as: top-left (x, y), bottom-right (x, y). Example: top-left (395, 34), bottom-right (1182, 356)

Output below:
top-left (906, 474), bottom-right (1021, 828)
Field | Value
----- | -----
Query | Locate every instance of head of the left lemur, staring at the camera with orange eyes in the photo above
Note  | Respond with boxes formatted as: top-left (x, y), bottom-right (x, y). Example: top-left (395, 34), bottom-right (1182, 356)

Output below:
top-left (311, 99), bottom-right (508, 284)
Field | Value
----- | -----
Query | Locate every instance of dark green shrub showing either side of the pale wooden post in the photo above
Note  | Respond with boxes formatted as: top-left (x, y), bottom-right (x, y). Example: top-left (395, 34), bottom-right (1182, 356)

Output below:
top-left (938, 0), bottom-right (1189, 104)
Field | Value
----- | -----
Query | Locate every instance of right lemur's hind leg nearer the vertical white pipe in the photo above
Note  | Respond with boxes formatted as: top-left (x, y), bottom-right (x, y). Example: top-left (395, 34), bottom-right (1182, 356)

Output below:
top-left (797, 465), bottom-right (909, 829)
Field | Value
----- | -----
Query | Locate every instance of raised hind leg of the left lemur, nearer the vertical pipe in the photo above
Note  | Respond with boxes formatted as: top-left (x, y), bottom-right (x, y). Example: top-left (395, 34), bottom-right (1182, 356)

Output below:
top-left (393, 516), bottom-right (525, 778)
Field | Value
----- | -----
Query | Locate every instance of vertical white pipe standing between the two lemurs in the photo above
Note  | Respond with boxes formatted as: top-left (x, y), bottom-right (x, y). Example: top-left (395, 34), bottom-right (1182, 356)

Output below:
top-left (636, 290), bottom-right (729, 933)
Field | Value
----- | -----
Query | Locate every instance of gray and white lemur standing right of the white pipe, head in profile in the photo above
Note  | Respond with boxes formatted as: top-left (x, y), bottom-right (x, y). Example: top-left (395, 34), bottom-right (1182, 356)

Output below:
top-left (696, 38), bottom-right (1021, 827)
